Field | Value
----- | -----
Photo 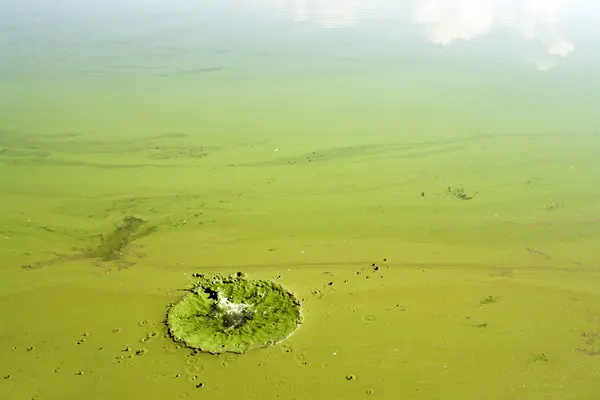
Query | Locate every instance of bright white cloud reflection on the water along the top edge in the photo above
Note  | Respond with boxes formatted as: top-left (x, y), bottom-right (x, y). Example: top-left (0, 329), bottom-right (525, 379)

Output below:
top-left (251, 0), bottom-right (581, 71)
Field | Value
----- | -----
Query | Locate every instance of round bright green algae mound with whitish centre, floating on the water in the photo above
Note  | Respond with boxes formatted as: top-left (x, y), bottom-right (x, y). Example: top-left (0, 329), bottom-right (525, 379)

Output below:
top-left (167, 273), bottom-right (302, 354)
